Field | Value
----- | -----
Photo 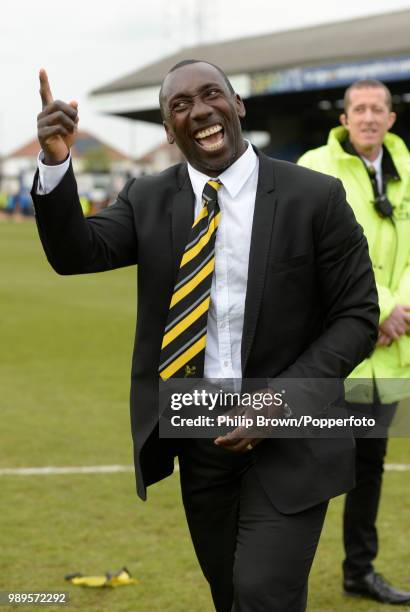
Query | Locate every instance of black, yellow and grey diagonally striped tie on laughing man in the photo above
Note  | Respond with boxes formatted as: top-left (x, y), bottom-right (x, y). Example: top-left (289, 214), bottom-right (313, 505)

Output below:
top-left (159, 179), bottom-right (222, 380)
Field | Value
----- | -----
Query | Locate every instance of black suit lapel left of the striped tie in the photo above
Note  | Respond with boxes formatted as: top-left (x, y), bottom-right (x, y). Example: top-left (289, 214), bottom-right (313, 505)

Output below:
top-left (172, 164), bottom-right (195, 283)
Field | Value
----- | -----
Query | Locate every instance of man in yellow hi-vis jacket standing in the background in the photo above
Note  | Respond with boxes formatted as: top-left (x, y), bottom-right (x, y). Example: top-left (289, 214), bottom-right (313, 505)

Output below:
top-left (299, 80), bottom-right (410, 605)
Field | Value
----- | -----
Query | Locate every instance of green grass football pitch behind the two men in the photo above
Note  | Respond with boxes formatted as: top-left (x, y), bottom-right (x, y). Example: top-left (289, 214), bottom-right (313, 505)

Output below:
top-left (0, 221), bottom-right (410, 612)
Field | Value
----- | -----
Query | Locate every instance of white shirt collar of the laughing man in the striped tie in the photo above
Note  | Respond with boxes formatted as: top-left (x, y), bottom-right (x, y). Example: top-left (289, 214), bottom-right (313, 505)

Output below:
top-left (188, 140), bottom-right (258, 198)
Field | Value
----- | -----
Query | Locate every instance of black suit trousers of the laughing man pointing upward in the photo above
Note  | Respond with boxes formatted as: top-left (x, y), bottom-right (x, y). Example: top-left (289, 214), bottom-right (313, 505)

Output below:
top-left (179, 440), bottom-right (328, 612)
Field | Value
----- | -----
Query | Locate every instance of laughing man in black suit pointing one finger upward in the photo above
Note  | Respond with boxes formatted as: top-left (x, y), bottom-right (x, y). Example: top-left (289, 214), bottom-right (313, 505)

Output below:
top-left (33, 60), bottom-right (378, 612)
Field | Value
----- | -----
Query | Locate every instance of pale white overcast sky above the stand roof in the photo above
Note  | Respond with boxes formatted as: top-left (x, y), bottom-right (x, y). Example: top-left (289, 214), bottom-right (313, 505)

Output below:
top-left (0, 0), bottom-right (410, 155)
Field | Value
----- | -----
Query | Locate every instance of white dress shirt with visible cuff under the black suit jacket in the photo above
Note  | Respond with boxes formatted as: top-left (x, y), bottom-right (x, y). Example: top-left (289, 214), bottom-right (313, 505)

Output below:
top-left (37, 143), bottom-right (259, 379)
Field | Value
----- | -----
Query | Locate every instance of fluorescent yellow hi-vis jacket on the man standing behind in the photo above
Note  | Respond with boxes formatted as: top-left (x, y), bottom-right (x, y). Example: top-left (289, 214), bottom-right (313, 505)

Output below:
top-left (298, 126), bottom-right (410, 403)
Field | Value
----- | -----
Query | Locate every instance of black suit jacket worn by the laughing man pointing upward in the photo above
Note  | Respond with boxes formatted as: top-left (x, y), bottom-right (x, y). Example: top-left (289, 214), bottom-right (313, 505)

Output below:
top-left (32, 151), bottom-right (379, 513)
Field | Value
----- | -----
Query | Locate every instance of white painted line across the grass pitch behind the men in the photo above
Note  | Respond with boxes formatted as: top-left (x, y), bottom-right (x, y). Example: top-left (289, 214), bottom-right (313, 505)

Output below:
top-left (0, 463), bottom-right (410, 476)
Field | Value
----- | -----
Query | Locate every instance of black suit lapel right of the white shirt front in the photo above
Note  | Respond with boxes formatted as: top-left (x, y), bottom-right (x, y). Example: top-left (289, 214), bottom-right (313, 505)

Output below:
top-left (241, 151), bottom-right (276, 372)
